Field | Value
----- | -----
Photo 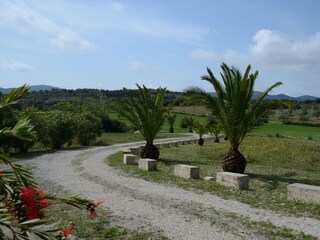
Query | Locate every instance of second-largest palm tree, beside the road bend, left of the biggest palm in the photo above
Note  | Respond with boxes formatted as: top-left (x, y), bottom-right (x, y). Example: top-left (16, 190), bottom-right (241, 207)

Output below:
top-left (113, 84), bottom-right (166, 160)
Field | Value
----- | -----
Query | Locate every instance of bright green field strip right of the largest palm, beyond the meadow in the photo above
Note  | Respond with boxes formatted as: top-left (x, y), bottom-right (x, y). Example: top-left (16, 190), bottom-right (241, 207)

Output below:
top-left (251, 123), bottom-right (320, 140)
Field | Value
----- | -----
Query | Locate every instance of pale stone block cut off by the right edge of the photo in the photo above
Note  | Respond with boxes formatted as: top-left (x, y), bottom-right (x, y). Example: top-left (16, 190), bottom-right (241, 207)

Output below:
top-left (287, 183), bottom-right (320, 203)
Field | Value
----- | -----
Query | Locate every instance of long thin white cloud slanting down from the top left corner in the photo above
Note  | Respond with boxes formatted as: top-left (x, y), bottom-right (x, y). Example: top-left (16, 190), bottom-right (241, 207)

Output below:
top-left (0, 1), bottom-right (95, 50)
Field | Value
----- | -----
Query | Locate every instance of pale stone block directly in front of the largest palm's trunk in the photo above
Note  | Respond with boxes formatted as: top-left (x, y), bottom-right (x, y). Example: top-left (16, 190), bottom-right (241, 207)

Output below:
top-left (216, 172), bottom-right (249, 190)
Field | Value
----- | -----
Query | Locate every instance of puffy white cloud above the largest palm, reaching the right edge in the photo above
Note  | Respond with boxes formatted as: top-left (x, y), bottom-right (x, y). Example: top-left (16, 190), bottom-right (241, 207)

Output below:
top-left (190, 29), bottom-right (320, 72)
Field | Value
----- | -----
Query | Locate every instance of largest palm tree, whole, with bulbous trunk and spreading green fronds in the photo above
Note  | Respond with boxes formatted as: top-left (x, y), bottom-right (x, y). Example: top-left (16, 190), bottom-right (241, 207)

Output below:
top-left (186, 63), bottom-right (282, 173)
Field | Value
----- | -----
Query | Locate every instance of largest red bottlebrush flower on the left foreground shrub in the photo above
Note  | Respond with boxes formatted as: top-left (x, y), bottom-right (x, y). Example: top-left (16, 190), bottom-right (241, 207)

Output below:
top-left (20, 186), bottom-right (49, 219)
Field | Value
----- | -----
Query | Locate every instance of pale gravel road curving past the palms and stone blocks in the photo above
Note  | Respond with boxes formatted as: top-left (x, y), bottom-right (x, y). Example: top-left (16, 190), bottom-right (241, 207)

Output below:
top-left (28, 138), bottom-right (320, 240)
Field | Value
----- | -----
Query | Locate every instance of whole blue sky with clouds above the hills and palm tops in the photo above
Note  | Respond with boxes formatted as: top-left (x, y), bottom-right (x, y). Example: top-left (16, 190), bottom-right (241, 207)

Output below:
top-left (0, 0), bottom-right (320, 97)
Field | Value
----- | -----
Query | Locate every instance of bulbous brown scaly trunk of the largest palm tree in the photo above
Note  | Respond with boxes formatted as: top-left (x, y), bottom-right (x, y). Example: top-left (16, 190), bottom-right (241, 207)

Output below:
top-left (221, 148), bottom-right (247, 173)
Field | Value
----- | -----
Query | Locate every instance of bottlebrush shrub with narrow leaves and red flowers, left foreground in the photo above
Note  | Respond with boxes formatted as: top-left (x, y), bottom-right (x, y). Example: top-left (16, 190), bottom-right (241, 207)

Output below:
top-left (0, 86), bottom-right (101, 240)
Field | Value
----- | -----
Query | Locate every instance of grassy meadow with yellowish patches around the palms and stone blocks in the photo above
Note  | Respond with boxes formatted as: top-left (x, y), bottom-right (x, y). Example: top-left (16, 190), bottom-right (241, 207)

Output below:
top-left (108, 137), bottom-right (320, 219)
